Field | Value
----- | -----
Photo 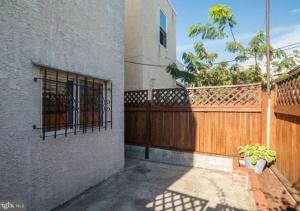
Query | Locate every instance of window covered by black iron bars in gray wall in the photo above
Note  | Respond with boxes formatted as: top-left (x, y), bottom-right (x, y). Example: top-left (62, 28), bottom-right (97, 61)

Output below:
top-left (34, 68), bottom-right (112, 139)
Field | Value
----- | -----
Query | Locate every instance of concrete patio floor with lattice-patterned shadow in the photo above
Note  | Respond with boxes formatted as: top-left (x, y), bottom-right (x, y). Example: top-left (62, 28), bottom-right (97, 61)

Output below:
top-left (55, 160), bottom-right (254, 211)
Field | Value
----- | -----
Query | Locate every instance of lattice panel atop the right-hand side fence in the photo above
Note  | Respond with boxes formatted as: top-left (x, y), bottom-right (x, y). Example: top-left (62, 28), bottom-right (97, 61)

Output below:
top-left (276, 70), bottom-right (300, 105)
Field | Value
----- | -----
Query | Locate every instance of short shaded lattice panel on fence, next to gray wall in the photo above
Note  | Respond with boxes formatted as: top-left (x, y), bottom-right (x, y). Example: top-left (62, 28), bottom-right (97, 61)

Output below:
top-left (124, 90), bottom-right (148, 105)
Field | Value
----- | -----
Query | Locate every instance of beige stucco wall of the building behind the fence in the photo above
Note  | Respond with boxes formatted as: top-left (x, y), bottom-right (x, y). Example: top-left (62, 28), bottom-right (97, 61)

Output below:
top-left (125, 0), bottom-right (176, 90)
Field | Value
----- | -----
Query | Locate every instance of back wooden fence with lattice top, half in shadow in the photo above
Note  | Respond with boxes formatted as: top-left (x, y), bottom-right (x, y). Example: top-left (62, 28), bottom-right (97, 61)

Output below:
top-left (125, 84), bottom-right (266, 156)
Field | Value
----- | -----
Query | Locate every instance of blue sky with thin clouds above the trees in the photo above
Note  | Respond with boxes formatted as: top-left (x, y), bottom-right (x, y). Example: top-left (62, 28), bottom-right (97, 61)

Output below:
top-left (172, 0), bottom-right (300, 61)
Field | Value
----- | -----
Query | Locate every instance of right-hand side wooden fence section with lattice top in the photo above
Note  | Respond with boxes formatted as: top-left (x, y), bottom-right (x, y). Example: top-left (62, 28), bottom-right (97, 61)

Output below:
top-left (271, 69), bottom-right (300, 191)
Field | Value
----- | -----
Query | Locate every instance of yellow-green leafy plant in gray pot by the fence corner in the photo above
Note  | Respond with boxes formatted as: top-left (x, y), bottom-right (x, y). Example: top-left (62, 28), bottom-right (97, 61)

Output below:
top-left (239, 144), bottom-right (276, 174)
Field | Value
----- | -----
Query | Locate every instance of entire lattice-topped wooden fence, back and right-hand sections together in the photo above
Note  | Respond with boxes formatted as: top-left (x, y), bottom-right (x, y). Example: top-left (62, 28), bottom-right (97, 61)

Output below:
top-left (125, 72), bottom-right (300, 193)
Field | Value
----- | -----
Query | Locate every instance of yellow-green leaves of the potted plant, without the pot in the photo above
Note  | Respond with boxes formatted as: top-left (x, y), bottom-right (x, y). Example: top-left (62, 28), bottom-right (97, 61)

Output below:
top-left (239, 144), bottom-right (276, 165)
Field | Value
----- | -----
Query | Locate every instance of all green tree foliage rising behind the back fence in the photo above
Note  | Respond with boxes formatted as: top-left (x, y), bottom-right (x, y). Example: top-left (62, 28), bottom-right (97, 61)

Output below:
top-left (167, 4), bottom-right (300, 87)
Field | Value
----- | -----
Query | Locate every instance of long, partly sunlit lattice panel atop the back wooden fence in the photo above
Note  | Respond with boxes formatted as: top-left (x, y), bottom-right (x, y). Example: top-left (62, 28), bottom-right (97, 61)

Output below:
top-left (152, 84), bottom-right (261, 107)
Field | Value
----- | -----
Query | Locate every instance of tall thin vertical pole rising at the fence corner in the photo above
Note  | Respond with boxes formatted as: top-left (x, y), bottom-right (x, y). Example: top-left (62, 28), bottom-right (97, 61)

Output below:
top-left (266, 0), bottom-right (271, 147)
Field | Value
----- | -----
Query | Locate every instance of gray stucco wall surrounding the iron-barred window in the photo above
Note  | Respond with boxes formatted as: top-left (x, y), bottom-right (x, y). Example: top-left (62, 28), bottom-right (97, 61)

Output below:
top-left (0, 0), bottom-right (124, 210)
